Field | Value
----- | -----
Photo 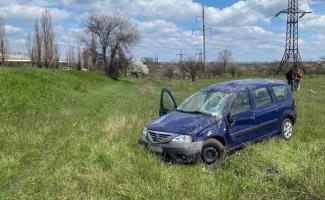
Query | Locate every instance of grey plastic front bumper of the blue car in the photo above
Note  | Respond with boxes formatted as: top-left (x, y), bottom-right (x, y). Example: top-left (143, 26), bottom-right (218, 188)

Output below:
top-left (140, 136), bottom-right (203, 164)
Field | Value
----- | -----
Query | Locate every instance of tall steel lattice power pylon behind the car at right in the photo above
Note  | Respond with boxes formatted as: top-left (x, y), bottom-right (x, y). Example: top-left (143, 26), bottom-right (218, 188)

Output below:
top-left (275, 0), bottom-right (311, 75)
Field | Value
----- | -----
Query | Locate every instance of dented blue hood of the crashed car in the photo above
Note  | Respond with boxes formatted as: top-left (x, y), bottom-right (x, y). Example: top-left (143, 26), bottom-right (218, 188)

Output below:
top-left (147, 111), bottom-right (216, 135)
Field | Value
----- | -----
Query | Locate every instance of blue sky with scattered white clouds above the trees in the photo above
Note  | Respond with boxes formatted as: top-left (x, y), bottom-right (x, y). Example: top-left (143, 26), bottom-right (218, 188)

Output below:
top-left (0, 0), bottom-right (325, 62)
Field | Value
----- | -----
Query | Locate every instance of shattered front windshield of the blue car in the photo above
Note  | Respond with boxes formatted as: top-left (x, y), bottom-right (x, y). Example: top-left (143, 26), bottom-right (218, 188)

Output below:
top-left (177, 91), bottom-right (232, 116)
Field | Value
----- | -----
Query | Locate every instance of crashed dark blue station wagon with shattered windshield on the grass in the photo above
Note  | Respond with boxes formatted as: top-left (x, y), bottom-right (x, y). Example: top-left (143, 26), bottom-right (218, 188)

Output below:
top-left (141, 80), bottom-right (297, 165)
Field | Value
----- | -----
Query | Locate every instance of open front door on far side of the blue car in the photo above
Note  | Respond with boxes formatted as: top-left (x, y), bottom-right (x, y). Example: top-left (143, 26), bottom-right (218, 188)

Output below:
top-left (159, 88), bottom-right (177, 116)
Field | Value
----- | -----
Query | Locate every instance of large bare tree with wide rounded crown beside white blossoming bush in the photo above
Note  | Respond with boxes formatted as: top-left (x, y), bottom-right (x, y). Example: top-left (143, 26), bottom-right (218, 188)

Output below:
top-left (85, 12), bottom-right (139, 79)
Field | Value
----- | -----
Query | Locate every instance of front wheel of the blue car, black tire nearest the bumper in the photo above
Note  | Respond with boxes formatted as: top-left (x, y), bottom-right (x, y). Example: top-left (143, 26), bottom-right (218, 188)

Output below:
top-left (201, 138), bottom-right (225, 166)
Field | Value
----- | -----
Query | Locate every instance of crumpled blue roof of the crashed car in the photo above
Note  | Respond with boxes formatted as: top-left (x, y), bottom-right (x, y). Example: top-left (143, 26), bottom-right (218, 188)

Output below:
top-left (202, 79), bottom-right (286, 92)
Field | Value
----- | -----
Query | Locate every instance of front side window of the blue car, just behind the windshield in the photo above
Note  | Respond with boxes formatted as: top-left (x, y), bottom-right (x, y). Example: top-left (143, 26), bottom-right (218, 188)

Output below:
top-left (231, 91), bottom-right (251, 115)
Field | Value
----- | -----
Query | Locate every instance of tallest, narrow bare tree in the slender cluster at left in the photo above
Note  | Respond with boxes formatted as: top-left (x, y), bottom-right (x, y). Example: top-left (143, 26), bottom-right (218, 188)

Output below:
top-left (40, 9), bottom-right (59, 68)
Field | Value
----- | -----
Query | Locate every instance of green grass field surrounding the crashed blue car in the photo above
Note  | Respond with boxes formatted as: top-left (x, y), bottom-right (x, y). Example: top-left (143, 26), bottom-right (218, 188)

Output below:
top-left (0, 68), bottom-right (325, 199)
